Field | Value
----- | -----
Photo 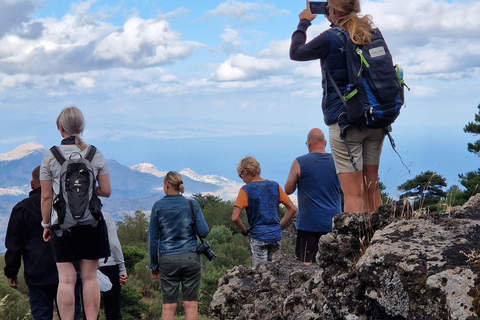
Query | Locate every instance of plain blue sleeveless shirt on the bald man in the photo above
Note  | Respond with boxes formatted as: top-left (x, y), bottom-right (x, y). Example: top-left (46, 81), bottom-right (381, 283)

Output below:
top-left (296, 152), bottom-right (342, 232)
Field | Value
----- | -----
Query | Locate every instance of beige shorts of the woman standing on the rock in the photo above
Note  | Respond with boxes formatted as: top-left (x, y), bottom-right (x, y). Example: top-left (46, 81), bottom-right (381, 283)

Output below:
top-left (329, 123), bottom-right (385, 174)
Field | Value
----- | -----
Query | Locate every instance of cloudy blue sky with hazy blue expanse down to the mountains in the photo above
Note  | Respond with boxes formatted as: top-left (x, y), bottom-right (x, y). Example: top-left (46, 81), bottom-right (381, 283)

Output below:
top-left (0, 0), bottom-right (480, 198)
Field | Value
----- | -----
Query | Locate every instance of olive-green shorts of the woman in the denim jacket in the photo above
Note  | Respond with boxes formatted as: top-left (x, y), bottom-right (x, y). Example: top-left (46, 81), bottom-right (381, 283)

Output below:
top-left (158, 252), bottom-right (202, 303)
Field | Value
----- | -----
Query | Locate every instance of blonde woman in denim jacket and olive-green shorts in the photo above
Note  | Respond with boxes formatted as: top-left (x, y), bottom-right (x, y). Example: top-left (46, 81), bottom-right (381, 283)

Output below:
top-left (148, 171), bottom-right (209, 320)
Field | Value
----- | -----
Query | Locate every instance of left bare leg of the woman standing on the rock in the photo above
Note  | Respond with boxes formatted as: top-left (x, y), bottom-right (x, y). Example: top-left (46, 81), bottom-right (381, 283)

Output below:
top-left (338, 171), bottom-right (365, 213)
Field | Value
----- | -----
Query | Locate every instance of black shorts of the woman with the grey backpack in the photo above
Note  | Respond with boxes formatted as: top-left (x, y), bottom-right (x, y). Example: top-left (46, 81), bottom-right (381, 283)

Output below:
top-left (50, 220), bottom-right (109, 262)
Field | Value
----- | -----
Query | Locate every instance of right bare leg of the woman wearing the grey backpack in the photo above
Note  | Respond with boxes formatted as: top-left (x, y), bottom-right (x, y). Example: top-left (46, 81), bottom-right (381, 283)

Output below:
top-left (79, 260), bottom-right (100, 320)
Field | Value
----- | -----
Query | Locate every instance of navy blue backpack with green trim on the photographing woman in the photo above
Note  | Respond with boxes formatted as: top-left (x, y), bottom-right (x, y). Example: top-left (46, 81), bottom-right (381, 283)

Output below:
top-left (327, 27), bottom-right (408, 128)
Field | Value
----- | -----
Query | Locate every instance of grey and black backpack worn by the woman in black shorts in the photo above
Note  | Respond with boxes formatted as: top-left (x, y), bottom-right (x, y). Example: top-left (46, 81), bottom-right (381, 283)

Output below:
top-left (50, 146), bottom-right (103, 230)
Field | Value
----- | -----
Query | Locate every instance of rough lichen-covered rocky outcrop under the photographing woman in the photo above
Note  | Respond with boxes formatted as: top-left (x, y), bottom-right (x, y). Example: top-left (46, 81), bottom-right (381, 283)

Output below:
top-left (210, 194), bottom-right (480, 320)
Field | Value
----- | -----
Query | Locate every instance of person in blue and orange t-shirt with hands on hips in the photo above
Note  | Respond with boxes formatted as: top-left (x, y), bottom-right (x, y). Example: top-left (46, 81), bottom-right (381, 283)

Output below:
top-left (232, 156), bottom-right (297, 267)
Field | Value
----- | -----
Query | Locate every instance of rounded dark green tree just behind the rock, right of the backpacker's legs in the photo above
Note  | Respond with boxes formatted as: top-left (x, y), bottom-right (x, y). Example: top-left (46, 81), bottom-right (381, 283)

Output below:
top-left (398, 171), bottom-right (447, 210)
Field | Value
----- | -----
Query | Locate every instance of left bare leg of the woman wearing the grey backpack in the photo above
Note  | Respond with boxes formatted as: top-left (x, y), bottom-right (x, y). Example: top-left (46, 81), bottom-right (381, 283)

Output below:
top-left (57, 262), bottom-right (77, 320)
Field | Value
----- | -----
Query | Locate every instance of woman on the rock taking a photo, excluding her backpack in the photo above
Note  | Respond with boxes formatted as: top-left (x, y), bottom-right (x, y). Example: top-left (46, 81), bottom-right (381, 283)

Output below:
top-left (290, 0), bottom-right (386, 212)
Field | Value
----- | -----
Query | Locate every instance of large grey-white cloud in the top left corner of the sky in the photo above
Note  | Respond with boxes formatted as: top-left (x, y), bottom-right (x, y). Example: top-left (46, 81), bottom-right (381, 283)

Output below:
top-left (0, 8), bottom-right (201, 75)
